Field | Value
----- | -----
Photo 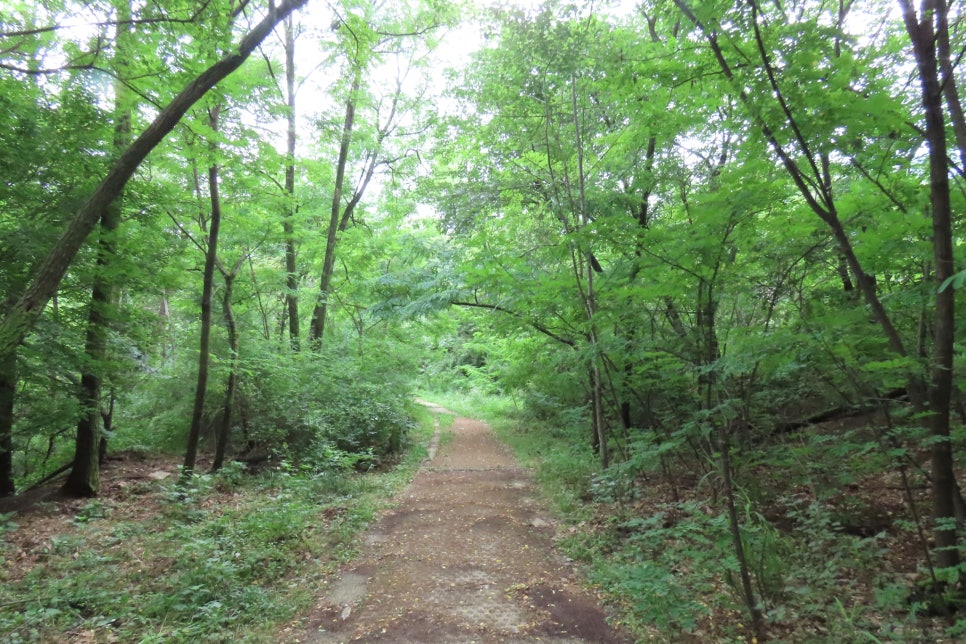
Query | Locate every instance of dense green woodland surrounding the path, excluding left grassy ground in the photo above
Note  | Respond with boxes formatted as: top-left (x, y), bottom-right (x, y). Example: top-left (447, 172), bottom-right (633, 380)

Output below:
top-left (0, 0), bottom-right (966, 641)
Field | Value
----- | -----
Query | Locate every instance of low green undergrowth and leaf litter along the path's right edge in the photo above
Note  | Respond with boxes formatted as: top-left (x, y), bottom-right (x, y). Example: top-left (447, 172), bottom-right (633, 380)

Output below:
top-left (433, 395), bottom-right (955, 642)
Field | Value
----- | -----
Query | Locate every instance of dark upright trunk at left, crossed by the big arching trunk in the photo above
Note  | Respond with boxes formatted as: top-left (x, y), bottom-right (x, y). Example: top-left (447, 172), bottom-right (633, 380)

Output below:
top-left (64, 5), bottom-right (132, 497)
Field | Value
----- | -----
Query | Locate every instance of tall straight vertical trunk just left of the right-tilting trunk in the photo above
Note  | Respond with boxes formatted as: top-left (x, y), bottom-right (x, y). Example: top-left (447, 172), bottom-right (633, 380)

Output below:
top-left (282, 17), bottom-right (301, 351)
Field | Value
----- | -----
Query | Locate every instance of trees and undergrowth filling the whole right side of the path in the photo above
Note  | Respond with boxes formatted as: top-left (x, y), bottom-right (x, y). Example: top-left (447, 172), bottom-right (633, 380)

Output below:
top-left (421, 0), bottom-right (966, 641)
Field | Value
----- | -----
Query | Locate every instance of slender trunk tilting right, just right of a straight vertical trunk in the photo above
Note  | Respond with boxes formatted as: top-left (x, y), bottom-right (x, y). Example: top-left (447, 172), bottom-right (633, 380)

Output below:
top-left (309, 63), bottom-right (362, 351)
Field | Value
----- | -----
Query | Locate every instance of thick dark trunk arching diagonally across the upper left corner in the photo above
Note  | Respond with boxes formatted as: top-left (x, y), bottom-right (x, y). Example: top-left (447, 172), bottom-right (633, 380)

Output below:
top-left (0, 0), bottom-right (308, 368)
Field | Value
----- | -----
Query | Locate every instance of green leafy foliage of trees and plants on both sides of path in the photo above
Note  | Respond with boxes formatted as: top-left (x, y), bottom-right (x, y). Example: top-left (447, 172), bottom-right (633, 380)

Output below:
top-left (0, 0), bottom-right (966, 641)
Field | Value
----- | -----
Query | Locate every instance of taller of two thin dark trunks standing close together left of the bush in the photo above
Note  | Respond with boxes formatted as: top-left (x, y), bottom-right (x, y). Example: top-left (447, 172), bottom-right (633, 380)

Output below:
top-left (182, 105), bottom-right (221, 478)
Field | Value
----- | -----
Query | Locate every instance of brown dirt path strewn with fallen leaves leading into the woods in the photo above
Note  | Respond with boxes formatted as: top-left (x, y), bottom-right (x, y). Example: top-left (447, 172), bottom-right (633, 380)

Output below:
top-left (283, 408), bottom-right (630, 644)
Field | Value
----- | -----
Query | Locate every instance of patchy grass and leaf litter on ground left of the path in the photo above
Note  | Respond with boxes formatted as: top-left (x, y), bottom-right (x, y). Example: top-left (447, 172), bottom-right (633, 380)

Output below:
top-left (0, 413), bottom-right (432, 643)
